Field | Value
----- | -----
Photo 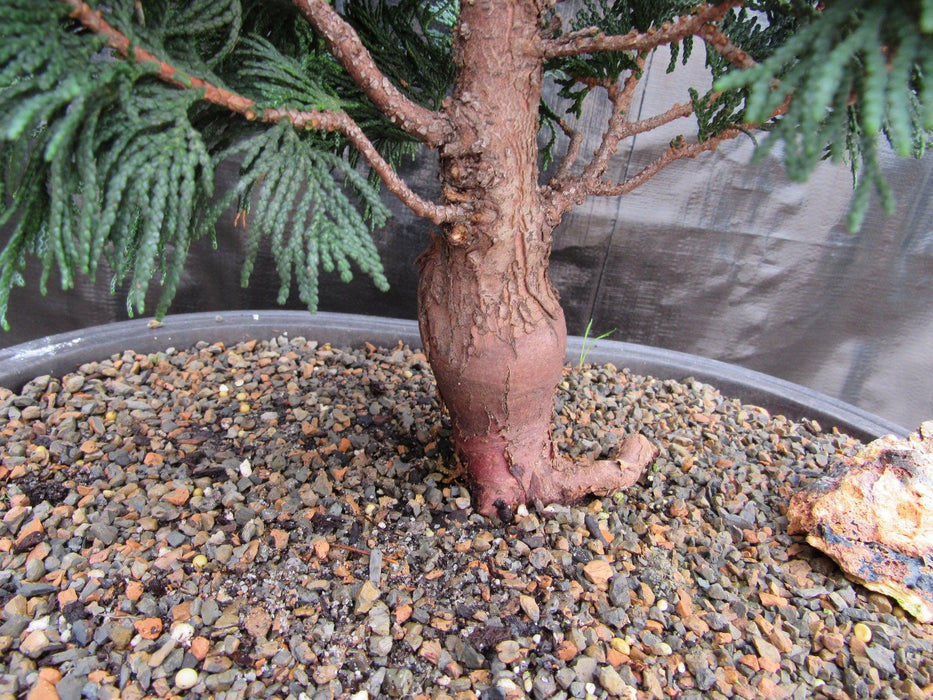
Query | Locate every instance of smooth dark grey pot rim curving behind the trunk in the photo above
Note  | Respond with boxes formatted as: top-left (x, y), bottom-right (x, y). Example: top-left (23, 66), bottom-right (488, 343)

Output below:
top-left (0, 310), bottom-right (909, 441)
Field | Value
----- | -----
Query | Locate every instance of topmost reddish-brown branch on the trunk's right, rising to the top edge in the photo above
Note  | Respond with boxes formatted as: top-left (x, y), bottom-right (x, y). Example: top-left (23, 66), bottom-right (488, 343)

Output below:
top-left (543, 0), bottom-right (742, 59)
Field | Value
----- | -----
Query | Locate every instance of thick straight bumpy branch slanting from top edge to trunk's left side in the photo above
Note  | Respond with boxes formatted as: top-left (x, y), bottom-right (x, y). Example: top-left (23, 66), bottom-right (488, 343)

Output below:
top-left (293, 0), bottom-right (453, 148)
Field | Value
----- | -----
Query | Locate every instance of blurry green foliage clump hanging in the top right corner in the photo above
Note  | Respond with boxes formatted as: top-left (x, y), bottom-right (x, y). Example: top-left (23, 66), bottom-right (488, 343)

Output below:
top-left (715, 0), bottom-right (933, 228)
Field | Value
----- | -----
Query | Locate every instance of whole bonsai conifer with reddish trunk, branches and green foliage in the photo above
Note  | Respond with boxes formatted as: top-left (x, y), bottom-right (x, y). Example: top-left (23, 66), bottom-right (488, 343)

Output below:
top-left (0, 0), bottom-right (933, 513)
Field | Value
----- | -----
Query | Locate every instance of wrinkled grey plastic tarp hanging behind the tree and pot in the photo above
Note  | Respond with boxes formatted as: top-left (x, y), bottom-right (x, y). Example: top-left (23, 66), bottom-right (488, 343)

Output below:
top-left (0, 46), bottom-right (933, 429)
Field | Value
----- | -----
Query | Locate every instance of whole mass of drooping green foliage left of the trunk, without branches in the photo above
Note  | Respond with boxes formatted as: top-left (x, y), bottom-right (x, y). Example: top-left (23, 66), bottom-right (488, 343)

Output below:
top-left (0, 0), bottom-right (396, 326)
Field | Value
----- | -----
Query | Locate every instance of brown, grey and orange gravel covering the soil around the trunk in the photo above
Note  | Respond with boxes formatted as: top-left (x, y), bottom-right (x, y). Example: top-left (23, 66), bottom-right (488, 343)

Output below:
top-left (0, 337), bottom-right (933, 700)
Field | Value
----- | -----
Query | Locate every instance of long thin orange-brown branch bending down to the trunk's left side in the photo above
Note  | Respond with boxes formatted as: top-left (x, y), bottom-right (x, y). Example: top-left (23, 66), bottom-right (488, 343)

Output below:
top-left (61, 0), bottom-right (465, 225)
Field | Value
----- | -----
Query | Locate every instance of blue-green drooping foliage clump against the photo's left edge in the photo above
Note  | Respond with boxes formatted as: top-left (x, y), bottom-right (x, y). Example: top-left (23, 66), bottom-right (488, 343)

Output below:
top-left (0, 1), bottom-right (202, 325)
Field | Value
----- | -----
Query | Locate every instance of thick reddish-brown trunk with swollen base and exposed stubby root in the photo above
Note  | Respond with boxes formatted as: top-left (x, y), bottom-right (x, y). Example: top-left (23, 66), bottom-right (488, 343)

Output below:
top-left (419, 0), bottom-right (655, 513)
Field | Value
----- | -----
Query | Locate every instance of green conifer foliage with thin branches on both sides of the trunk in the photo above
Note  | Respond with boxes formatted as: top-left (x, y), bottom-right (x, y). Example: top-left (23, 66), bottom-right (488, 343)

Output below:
top-left (0, 0), bottom-right (933, 325)
